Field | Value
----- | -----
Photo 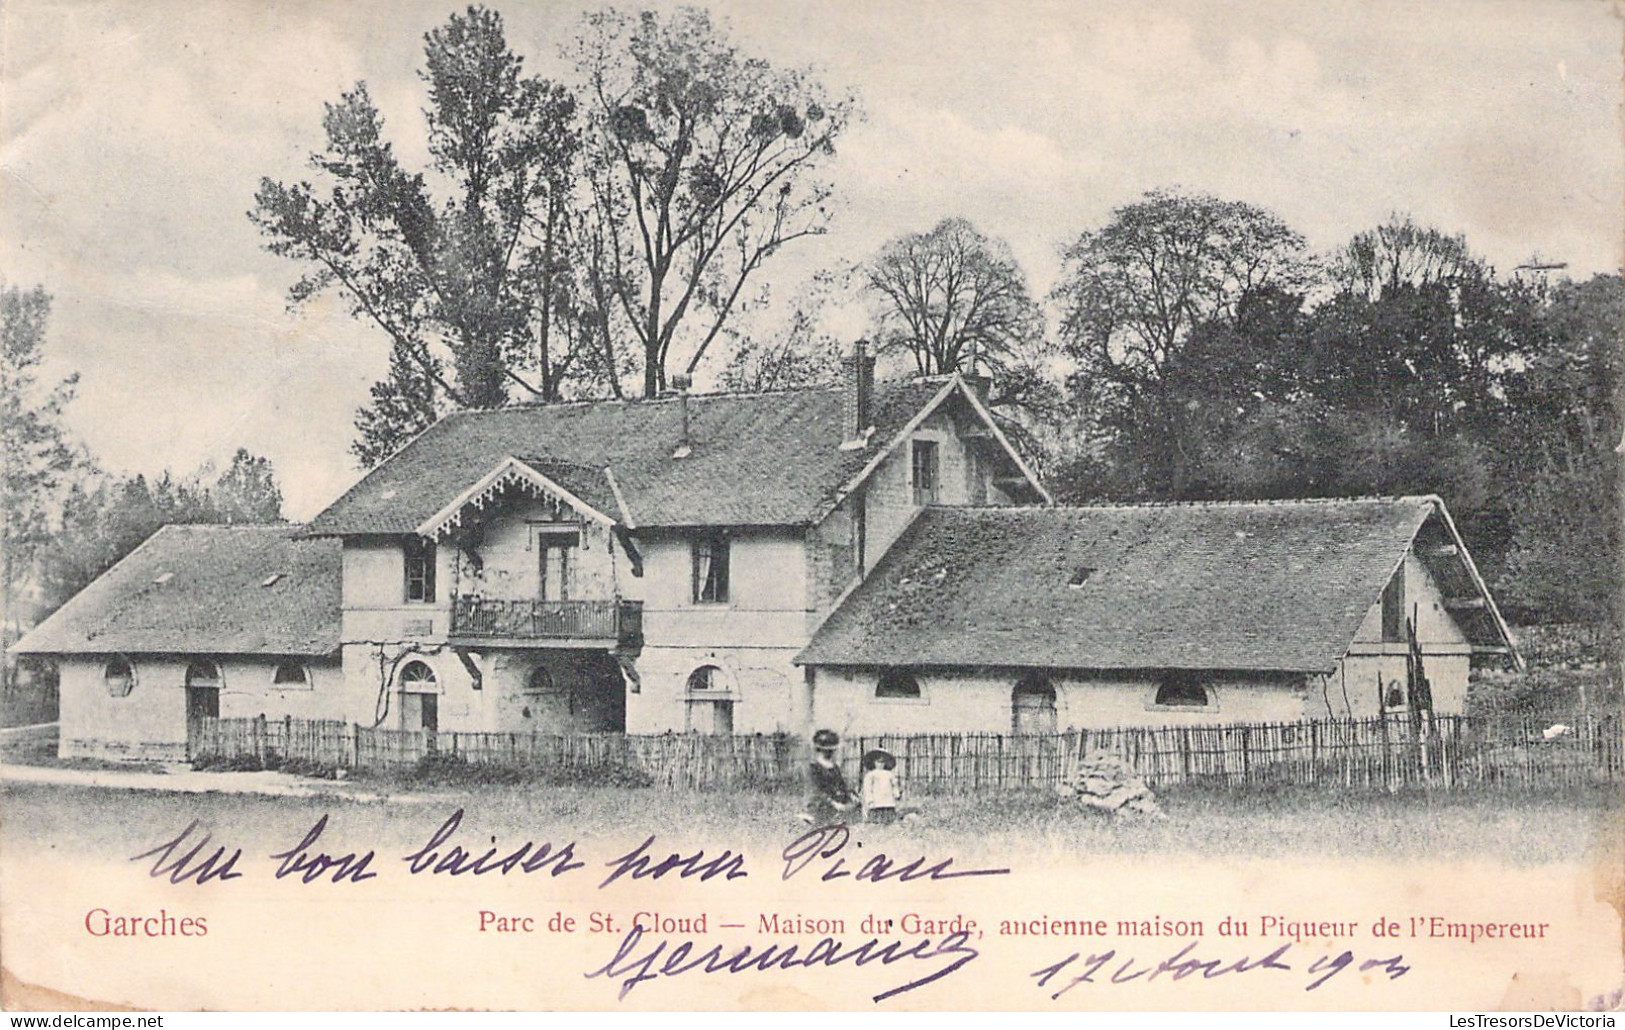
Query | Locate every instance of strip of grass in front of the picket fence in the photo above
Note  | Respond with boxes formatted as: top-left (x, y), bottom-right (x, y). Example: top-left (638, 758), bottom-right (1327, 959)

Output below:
top-left (0, 773), bottom-right (1625, 864)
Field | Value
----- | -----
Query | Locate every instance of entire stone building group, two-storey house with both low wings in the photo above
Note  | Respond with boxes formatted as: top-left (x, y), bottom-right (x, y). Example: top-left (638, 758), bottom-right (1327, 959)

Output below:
top-left (13, 351), bottom-right (1516, 759)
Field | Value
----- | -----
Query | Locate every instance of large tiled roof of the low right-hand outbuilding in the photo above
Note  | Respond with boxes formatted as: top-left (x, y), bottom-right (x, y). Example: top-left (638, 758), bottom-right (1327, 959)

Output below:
top-left (798, 497), bottom-right (1503, 673)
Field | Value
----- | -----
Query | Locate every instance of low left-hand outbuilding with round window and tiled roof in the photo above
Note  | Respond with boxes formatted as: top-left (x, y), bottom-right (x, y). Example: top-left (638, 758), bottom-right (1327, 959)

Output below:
top-left (11, 525), bottom-right (342, 762)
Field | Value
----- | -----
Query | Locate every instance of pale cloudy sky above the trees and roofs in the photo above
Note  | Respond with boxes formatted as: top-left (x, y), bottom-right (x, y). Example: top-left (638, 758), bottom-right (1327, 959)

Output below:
top-left (0, 0), bottom-right (1625, 518)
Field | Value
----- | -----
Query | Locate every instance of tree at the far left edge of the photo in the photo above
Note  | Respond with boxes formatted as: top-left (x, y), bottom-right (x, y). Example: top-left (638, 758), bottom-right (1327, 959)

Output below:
top-left (0, 283), bottom-right (81, 640)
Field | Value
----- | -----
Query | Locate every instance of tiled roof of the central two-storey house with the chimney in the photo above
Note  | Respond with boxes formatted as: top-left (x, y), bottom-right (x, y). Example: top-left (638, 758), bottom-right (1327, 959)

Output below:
top-left (307, 380), bottom-right (946, 534)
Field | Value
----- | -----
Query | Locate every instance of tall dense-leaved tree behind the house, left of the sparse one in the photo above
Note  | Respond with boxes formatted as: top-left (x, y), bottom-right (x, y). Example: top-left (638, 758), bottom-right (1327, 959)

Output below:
top-left (249, 6), bottom-right (592, 460)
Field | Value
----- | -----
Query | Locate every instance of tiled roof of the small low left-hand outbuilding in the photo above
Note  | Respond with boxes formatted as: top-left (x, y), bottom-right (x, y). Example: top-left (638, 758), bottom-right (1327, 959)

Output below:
top-left (11, 525), bottom-right (340, 656)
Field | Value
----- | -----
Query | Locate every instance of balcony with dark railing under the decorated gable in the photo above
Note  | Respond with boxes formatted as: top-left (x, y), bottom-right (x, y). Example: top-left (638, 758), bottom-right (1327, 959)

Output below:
top-left (452, 596), bottom-right (644, 648)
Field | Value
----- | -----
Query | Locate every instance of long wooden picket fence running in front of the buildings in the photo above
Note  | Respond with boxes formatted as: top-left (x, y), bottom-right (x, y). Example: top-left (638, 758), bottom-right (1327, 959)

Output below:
top-left (189, 715), bottom-right (1625, 794)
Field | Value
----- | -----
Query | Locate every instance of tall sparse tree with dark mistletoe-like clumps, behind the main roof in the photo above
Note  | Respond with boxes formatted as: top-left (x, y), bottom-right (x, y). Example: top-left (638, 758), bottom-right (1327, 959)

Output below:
top-left (574, 6), bottom-right (853, 396)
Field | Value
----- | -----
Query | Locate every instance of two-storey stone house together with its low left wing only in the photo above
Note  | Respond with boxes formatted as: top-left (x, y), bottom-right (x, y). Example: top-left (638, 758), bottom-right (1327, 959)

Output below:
top-left (22, 351), bottom-right (1050, 759)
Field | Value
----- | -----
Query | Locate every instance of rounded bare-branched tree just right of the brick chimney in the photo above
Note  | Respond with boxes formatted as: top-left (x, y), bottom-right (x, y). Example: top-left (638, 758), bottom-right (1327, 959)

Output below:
top-left (865, 218), bottom-right (1043, 385)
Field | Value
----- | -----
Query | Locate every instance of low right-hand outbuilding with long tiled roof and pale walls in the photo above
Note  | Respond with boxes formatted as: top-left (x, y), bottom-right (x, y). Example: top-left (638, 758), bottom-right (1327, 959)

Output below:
top-left (796, 497), bottom-right (1518, 733)
